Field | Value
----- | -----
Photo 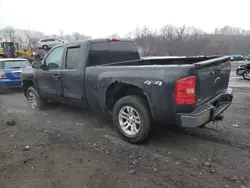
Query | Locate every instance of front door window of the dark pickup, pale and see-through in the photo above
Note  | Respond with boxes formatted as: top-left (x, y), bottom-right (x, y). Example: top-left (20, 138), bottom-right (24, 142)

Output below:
top-left (45, 47), bottom-right (63, 69)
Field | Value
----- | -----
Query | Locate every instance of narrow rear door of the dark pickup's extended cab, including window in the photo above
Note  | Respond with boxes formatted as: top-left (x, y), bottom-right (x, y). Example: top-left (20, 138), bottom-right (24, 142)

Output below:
top-left (62, 44), bottom-right (85, 101)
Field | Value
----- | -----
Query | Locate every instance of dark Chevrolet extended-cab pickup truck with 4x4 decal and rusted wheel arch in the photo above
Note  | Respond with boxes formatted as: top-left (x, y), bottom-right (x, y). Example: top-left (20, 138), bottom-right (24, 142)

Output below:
top-left (21, 39), bottom-right (233, 143)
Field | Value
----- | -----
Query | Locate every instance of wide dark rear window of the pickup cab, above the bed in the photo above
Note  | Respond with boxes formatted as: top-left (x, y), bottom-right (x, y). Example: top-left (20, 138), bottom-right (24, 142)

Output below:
top-left (88, 41), bottom-right (140, 66)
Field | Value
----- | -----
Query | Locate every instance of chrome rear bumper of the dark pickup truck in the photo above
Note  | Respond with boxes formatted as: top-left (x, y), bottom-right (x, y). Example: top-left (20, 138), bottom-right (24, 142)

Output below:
top-left (177, 88), bottom-right (233, 128)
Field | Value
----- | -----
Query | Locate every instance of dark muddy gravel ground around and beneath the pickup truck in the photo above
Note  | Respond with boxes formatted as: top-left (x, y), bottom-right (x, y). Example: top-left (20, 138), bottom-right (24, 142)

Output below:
top-left (0, 62), bottom-right (250, 188)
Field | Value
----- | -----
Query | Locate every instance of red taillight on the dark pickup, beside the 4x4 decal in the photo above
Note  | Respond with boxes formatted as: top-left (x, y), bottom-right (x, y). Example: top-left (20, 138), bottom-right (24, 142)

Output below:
top-left (175, 76), bottom-right (196, 105)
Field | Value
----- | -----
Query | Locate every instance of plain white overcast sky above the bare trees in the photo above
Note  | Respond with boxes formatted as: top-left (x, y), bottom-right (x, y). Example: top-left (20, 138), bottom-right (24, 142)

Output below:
top-left (0, 0), bottom-right (250, 37)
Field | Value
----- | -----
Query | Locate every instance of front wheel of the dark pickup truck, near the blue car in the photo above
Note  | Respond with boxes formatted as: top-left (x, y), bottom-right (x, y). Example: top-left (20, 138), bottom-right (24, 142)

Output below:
top-left (26, 87), bottom-right (46, 111)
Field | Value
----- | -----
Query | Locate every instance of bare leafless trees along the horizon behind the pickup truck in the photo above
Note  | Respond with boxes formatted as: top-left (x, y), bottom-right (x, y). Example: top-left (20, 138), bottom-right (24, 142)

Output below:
top-left (0, 25), bottom-right (250, 56)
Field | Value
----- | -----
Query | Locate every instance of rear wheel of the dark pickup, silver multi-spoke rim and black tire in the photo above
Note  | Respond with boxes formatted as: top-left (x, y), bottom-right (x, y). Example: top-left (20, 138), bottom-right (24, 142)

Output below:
top-left (113, 95), bottom-right (152, 144)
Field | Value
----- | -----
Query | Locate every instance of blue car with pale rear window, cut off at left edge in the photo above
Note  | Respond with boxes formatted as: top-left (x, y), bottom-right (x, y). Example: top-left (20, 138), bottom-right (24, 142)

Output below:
top-left (0, 58), bottom-right (31, 92)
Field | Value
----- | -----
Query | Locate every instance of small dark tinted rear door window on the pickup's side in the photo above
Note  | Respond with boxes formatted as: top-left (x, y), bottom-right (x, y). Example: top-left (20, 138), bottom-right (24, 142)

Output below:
top-left (65, 46), bottom-right (81, 69)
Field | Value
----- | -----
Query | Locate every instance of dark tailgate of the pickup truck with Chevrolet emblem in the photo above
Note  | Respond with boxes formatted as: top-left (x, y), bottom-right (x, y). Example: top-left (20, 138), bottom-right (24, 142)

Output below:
top-left (195, 56), bottom-right (231, 105)
